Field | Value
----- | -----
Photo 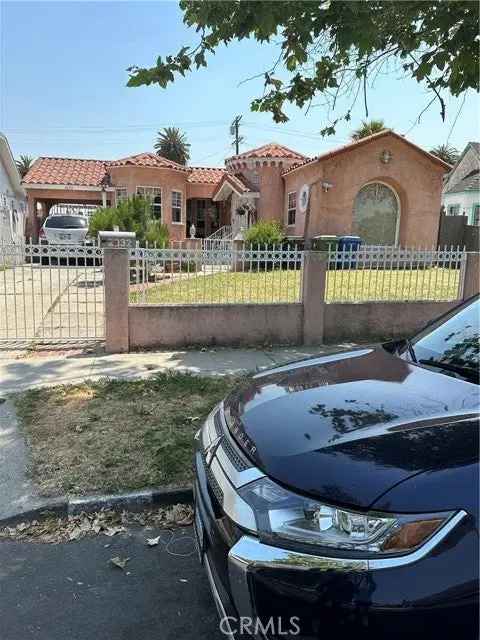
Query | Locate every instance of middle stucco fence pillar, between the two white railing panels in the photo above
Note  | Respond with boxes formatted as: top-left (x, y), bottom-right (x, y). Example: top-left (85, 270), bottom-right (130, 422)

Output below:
top-left (302, 251), bottom-right (328, 345)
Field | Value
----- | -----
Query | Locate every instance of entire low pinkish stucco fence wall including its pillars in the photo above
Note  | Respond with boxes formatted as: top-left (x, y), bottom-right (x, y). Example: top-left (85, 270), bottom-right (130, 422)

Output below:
top-left (104, 249), bottom-right (479, 353)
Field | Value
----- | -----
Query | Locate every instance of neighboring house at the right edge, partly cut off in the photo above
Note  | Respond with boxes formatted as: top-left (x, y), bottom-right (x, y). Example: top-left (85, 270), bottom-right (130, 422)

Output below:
top-left (442, 142), bottom-right (480, 226)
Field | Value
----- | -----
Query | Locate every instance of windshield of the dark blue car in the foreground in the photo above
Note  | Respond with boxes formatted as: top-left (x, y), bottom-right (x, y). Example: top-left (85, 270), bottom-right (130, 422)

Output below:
top-left (411, 297), bottom-right (480, 379)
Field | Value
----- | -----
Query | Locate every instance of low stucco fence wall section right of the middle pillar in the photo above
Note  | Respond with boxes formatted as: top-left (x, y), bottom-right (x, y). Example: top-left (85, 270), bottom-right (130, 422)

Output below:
top-left (324, 300), bottom-right (460, 343)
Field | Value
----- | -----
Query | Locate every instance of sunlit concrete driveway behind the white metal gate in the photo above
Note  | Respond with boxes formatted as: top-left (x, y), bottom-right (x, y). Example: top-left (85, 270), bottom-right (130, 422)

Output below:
top-left (0, 264), bottom-right (103, 341)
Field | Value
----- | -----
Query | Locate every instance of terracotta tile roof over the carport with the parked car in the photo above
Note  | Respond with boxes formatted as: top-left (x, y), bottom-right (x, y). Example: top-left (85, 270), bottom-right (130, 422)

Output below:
top-left (22, 157), bottom-right (107, 187)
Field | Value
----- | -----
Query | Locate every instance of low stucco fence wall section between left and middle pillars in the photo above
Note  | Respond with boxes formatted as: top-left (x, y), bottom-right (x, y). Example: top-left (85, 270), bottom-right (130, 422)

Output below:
top-left (128, 304), bottom-right (303, 349)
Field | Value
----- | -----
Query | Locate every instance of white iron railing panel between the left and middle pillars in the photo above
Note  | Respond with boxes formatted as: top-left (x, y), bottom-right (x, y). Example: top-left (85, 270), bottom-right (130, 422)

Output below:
top-left (130, 245), bottom-right (303, 304)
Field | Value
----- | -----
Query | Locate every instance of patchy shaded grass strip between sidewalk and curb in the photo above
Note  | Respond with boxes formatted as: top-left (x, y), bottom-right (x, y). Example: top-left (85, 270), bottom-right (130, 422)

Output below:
top-left (15, 373), bottom-right (235, 495)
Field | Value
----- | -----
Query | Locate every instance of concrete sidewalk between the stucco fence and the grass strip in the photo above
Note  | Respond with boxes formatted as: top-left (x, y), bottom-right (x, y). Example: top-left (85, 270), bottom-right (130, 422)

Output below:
top-left (0, 344), bottom-right (354, 396)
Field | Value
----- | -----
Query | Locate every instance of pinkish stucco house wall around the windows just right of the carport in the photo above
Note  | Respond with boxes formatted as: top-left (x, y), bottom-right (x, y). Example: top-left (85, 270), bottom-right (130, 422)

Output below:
top-left (109, 166), bottom-right (187, 240)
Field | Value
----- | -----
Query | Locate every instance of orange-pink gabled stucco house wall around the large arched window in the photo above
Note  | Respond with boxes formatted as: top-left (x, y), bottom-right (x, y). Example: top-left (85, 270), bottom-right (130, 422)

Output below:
top-left (284, 136), bottom-right (445, 246)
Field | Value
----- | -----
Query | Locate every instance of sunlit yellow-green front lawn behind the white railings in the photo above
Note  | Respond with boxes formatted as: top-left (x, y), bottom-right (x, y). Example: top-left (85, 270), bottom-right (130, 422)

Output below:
top-left (130, 267), bottom-right (460, 304)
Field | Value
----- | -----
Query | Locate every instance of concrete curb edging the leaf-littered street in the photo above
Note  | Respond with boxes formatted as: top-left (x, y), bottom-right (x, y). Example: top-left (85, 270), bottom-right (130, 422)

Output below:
top-left (0, 487), bottom-right (193, 527)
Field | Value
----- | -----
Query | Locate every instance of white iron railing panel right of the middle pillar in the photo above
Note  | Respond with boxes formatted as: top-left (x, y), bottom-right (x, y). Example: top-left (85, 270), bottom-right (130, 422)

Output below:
top-left (326, 246), bottom-right (466, 302)
